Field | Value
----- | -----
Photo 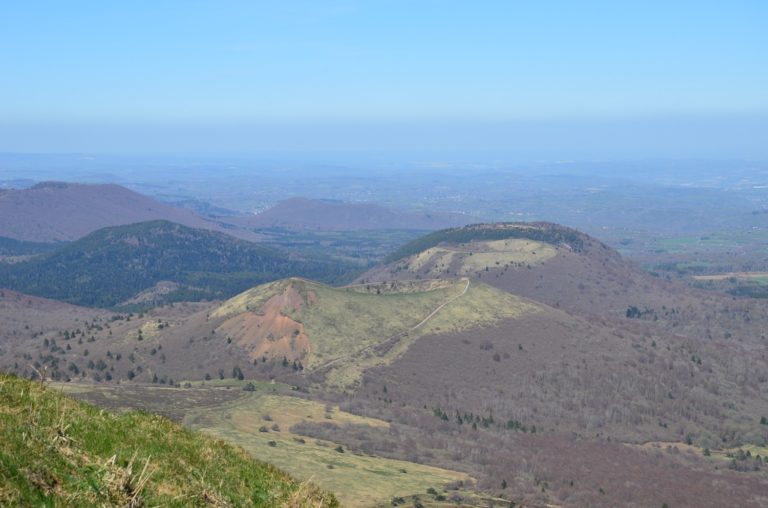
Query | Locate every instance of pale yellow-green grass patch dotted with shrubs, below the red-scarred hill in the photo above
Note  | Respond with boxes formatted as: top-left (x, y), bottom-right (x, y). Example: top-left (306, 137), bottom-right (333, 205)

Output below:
top-left (184, 392), bottom-right (468, 506)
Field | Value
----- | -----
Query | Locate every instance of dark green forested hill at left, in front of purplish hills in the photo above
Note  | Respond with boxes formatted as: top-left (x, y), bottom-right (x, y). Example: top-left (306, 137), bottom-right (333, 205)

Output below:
top-left (0, 221), bottom-right (353, 307)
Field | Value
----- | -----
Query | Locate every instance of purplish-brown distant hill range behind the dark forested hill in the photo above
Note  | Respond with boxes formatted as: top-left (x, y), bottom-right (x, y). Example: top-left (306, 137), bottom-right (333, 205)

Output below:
top-left (0, 182), bottom-right (476, 247)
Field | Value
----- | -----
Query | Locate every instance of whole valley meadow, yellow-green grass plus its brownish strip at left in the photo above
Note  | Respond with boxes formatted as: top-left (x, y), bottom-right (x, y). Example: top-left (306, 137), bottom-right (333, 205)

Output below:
top-left (56, 380), bottom-right (473, 506)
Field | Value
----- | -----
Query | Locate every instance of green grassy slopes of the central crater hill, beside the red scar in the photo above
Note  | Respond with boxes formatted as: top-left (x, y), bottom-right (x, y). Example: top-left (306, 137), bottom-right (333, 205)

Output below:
top-left (212, 279), bottom-right (537, 386)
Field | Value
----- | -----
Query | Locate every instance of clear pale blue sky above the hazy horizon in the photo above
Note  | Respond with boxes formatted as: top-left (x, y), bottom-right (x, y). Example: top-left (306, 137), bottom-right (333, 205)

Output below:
top-left (0, 0), bottom-right (768, 158)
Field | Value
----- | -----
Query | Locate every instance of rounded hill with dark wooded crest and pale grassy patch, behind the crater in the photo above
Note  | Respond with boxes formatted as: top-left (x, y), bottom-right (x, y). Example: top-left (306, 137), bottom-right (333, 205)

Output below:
top-left (366, 223), bottom-right (656, 317)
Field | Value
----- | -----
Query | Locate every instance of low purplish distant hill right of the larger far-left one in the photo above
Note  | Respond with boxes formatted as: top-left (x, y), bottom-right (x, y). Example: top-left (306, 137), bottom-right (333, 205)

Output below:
top-left (231, 198), bottom-right (471, 231)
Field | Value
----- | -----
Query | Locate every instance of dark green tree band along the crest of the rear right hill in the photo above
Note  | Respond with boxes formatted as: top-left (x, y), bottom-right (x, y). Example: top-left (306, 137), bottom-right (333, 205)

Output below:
top-left (385, 222), bottom-right (584, 263)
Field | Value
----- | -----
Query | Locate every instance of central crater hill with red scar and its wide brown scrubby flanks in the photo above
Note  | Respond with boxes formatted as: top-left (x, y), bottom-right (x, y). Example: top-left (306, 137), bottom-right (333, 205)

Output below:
top-left (6, 266), bottom-right (768, 446)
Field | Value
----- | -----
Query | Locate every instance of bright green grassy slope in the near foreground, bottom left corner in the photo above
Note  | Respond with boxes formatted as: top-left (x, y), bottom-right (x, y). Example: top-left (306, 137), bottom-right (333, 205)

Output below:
top-left (0, 375), bottom-right (338, 507)
